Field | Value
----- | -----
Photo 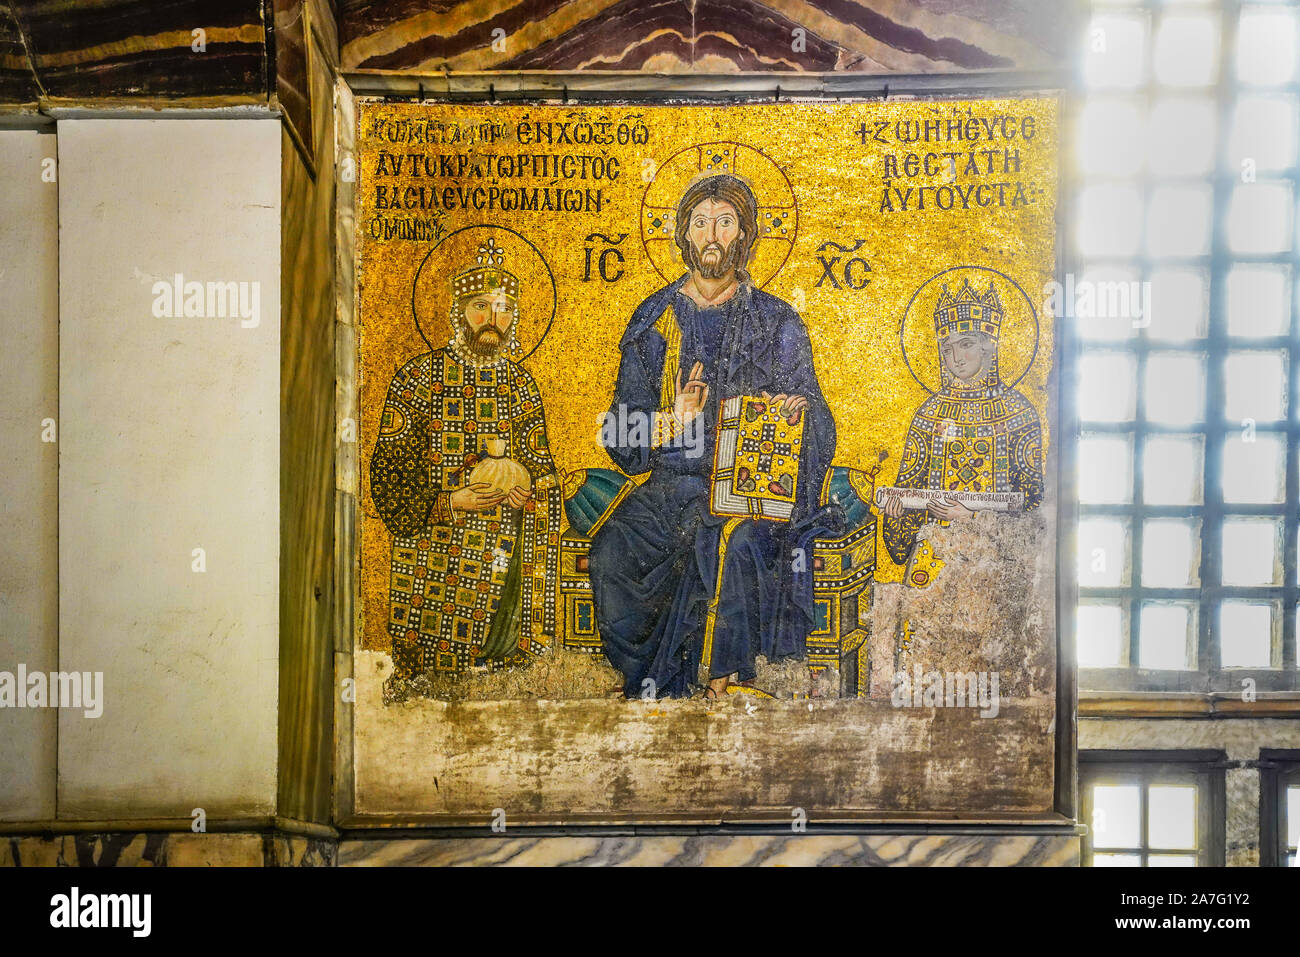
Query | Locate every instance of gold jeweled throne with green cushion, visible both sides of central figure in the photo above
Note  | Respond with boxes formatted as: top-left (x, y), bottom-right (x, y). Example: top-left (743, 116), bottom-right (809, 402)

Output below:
top-left (556, 465), bottom-right (876, 697)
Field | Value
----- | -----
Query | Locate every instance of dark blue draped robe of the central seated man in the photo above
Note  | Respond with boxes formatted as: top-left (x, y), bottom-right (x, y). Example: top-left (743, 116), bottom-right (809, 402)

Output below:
top-left (589, 277), bottom-right (845, 697)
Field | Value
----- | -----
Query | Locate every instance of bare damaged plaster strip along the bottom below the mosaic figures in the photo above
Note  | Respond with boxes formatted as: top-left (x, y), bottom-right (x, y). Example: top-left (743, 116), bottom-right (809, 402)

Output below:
top-left (351, 642), bottom-right (1054, 826)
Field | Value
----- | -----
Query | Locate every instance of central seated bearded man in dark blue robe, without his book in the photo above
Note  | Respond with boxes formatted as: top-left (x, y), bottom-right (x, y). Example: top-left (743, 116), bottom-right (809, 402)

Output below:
top-left (590, 174), bottom-right (842, 697)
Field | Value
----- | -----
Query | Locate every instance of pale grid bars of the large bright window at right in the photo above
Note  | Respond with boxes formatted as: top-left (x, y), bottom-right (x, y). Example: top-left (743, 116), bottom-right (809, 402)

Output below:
top-left (1067, 0), bottom-right (1300, 692)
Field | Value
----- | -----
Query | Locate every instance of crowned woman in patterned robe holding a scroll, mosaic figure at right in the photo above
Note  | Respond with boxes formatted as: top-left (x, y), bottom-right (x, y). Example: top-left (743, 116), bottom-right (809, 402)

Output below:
top-left (881, 280), bottom-right (1043, 564)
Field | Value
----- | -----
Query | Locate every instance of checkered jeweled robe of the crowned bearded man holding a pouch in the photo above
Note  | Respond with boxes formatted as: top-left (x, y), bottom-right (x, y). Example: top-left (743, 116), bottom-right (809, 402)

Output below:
top-left (371, 347), bottom-right (562, 674)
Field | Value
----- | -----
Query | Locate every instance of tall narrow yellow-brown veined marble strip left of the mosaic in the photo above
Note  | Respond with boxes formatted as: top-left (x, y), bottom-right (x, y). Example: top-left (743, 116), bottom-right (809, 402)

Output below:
top-left (277, 4), bottom-right (341, 823)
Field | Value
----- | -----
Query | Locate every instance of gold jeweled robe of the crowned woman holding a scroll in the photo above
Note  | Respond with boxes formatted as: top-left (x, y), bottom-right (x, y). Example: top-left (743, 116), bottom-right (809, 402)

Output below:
top-left (883, 368), bottom-right (1043, 564)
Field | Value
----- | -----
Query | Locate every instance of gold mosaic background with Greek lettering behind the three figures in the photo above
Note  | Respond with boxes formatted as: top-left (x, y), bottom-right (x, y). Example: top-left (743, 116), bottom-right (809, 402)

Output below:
top-left (356, 98), bottom-right (1058, 649)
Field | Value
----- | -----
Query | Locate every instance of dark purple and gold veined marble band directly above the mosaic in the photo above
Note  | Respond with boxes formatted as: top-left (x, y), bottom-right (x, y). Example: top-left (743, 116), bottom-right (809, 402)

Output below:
top-left (339, 0), bottom-right (1080, 73)
